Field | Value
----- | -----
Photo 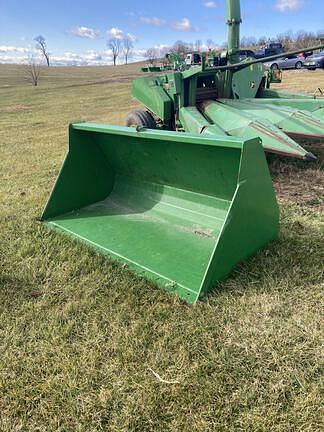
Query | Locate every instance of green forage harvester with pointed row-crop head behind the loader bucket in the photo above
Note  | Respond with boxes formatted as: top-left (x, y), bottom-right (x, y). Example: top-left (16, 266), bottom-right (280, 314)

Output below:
top-left (127, 0), bottom-right (324, 160)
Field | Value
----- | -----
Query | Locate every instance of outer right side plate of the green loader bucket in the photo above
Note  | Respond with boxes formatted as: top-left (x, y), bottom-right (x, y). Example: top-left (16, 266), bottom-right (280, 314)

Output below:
top-left (201, 140), bottom-right (279, 300)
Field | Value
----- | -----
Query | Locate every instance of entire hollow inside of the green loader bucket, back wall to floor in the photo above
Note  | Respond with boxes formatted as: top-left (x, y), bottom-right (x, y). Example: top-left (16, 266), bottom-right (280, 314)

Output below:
top-left (43, 123), bottom-right (240, 301)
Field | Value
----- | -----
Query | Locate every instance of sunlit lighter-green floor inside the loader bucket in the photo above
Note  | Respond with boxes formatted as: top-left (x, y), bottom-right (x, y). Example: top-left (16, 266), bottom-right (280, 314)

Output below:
top-left (51, 176), bottom-right (230, 295)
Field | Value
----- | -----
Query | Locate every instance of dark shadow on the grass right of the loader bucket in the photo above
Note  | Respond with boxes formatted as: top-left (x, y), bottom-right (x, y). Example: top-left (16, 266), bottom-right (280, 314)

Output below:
top-left (208, 208), bottom-right (323, 299)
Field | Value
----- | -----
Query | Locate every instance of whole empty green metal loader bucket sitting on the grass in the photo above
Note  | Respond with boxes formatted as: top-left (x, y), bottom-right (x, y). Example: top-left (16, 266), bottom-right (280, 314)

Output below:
top-left (42, 123), bottom-right (279, 303)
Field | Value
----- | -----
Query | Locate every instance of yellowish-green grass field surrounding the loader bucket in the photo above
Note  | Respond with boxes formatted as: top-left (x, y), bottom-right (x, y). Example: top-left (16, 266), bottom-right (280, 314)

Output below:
top-left (0, 65), bottom-right (324, 432)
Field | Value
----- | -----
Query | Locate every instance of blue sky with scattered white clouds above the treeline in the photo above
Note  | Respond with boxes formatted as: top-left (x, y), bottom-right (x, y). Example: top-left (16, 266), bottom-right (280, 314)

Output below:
top-left (0, 0), bottom-right (324, 64)
